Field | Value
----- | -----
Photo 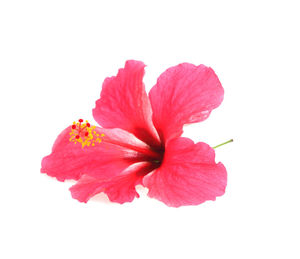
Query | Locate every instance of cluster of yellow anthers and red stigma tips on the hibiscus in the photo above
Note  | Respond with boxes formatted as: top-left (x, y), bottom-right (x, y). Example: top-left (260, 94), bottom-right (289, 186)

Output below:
top-left (69, 119), bottom-right (104, 148)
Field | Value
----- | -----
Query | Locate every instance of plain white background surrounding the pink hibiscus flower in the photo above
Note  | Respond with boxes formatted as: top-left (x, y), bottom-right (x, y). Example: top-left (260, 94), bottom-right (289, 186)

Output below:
top-left (0, 0), bottom-right (300, 259)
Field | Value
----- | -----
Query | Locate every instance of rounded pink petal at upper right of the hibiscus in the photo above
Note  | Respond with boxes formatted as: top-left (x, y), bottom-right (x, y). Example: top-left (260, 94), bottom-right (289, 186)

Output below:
top-left (149, 63), bottom-right (224, 142)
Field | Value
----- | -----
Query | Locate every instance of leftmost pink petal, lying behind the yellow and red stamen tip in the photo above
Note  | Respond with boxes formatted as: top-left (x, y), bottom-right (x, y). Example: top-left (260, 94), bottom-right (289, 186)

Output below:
top-left (41, 126), bottom-right (155, 181)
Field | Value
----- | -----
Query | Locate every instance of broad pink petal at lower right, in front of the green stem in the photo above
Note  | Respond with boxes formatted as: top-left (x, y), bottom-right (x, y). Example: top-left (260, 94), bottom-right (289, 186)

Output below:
top-left (143, 138), bottom-right (227, 207)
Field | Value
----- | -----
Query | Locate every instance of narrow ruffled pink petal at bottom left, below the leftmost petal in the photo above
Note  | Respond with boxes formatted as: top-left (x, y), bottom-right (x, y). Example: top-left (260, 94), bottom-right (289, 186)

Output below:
top-left (70, 162), bottom-right (153, 204)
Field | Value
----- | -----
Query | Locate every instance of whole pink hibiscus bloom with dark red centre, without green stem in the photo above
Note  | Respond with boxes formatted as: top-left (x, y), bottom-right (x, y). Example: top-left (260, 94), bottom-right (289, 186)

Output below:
top-left (41, 60), bottom-right (227, 207)
